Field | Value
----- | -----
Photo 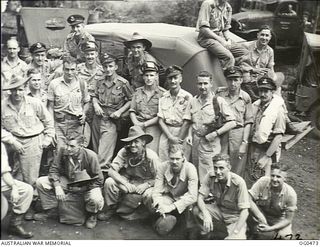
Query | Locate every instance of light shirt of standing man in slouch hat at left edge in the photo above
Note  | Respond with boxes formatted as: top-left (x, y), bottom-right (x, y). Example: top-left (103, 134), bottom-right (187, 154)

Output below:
top-left (1, 96), bottom-right (54, 137)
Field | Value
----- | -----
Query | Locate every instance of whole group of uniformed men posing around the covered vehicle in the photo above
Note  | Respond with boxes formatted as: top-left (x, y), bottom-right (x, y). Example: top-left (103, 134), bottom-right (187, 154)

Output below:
top-left (1, 0), bottom-right (297, 239)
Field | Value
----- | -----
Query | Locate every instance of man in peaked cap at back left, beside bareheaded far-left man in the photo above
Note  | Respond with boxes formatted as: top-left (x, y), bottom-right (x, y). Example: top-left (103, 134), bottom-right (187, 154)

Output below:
top-left (28, 42), bottom-right (62, 92)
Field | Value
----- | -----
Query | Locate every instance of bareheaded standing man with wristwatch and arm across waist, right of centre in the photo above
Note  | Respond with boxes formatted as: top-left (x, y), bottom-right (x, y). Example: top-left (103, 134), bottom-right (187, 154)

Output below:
top-left (182, 71), bottom-right (236, 183)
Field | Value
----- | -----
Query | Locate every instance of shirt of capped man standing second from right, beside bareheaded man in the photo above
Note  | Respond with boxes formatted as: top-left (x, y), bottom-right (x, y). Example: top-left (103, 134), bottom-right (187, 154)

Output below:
top-left (218, 88), bottom-right (253, 127)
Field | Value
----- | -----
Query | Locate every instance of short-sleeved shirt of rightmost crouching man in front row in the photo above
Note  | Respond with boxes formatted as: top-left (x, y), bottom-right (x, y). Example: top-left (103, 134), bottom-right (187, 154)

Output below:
top-left (249, 176), bottom-right (297, 218)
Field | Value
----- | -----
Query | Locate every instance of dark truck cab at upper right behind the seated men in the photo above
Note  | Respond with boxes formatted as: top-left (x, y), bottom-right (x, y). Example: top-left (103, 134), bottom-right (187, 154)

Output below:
top-left (231, 0), bottom-right (303, 49)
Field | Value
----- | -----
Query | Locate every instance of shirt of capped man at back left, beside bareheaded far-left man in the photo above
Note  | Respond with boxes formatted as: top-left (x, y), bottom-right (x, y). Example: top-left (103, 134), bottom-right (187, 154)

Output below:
top-left (27, 59), bottom-right (63, 92)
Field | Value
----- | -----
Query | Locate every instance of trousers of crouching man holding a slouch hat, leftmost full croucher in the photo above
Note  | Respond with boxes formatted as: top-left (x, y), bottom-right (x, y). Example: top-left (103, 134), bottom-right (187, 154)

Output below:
top-left (37, 176), bottom-right (104, 213)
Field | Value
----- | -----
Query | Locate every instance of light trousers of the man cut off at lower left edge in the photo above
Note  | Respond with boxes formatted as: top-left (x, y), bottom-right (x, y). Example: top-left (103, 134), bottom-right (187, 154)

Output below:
top-left (1, 180), bottom-right (33, 214)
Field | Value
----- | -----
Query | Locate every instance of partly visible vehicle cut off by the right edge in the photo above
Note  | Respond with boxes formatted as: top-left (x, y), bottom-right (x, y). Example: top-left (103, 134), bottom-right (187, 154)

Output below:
top-left (288, 33), bottom-right (320, 138)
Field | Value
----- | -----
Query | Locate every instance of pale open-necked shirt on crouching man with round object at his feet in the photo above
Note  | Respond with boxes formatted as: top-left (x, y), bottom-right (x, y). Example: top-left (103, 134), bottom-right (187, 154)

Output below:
top-left (152, 161), bottom-right (198, 214)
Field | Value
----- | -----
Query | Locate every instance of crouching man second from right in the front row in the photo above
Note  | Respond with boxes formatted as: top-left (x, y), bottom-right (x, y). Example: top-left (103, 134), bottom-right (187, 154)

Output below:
top-left (193, 154), bottom-right (250, 239)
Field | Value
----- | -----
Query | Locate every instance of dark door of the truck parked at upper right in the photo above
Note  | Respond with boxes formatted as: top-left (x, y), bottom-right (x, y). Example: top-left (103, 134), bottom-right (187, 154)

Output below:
top-left (273, 1), bottom-right (303, 48)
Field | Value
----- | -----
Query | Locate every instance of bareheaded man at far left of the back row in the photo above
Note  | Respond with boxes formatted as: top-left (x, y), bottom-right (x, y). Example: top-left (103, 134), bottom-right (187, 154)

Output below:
top-left (1, 37), bottom-right (28, 83)
